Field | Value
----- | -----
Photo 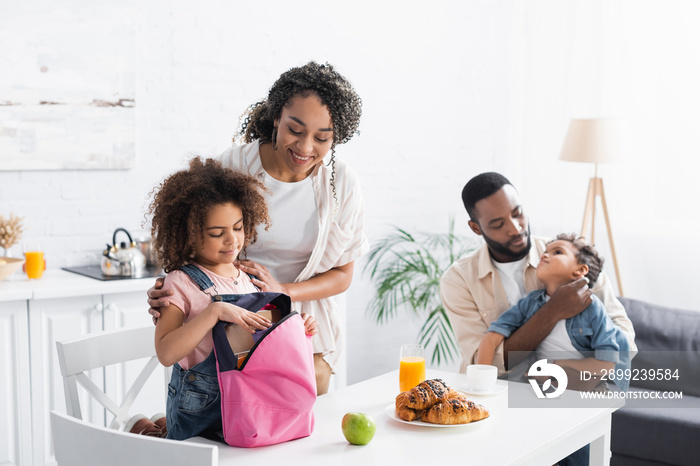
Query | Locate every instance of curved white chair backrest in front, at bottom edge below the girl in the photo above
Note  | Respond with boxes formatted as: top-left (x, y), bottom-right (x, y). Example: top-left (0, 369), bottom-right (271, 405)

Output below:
top-left (51, 411), bottom-right (219, 466)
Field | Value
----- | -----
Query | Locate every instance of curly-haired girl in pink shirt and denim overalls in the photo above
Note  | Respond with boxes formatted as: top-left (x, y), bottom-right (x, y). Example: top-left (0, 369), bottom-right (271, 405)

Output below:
top-left (149, 157), bottom-right (318, 440)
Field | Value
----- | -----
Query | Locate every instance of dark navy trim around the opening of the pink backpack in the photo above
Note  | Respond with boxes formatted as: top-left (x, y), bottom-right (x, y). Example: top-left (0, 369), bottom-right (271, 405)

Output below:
top-left (211, 292), bottom-right (292, 372)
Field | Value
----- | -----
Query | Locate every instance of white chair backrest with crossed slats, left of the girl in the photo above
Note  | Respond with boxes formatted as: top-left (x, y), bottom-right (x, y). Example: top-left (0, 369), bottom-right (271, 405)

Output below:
top-left (56, 326), bottom-right (169, 429)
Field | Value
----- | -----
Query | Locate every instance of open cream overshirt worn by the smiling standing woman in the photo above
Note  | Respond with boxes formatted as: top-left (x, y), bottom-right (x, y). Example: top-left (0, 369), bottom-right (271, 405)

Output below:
top-left (219, 141), bottom-right (369, 367)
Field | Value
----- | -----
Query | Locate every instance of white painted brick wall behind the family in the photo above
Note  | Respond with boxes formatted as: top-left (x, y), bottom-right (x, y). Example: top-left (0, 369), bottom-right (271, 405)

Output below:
top-left (0, 0), bottom-right (697, 381)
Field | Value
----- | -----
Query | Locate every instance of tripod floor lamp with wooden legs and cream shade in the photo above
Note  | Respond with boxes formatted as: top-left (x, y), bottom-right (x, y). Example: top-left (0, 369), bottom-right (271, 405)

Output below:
top-left (559, 118), bottom-right (623, 296)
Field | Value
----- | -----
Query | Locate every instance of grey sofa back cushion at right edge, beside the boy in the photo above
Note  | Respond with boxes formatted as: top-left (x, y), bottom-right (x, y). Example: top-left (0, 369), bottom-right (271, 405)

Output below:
top-left (620, 298), bottom-right (700, 396)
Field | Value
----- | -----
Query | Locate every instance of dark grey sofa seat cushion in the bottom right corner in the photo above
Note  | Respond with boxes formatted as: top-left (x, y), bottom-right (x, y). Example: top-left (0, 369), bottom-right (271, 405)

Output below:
top-left (610, 397), bottom-right (700, 466)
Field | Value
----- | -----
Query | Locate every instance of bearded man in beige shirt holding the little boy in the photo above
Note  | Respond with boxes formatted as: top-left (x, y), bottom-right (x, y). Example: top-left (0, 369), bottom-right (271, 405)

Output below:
top-left (440, 172), bottom-right (637, 373)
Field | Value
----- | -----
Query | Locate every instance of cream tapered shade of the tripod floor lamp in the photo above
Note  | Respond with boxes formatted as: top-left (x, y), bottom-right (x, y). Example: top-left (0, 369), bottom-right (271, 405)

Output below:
top-left (559, 118), bottom-right (625, 163)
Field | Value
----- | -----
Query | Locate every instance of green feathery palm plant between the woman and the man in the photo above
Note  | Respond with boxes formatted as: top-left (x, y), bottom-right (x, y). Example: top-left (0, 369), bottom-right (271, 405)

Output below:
top-left (363, 219), bottom-right (479, 365)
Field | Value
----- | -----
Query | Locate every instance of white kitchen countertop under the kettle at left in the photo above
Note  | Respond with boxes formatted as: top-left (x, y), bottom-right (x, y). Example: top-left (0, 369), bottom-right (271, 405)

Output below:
top-left (0, 269), bottom-right (155, 302)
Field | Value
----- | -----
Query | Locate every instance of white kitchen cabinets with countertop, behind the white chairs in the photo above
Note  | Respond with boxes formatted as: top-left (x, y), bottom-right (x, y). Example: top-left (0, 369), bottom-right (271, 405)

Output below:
top-left (0, 270), bottom-right (160, 466)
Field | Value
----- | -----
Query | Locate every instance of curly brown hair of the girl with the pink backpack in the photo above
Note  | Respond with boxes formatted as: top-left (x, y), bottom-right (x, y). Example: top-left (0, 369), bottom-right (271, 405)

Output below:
top-left (148, 157), bottom-right (270, 273)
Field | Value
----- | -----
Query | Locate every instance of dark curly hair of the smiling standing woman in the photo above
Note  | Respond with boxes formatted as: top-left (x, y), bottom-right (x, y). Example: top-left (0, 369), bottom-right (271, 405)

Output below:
top-left (238, 62), bottom-right (362, 148)
